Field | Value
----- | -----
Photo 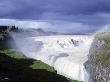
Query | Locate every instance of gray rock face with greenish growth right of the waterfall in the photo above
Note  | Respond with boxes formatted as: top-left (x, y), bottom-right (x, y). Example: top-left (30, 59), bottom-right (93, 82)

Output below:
top-left (85, 33), bottom-right (110, 82)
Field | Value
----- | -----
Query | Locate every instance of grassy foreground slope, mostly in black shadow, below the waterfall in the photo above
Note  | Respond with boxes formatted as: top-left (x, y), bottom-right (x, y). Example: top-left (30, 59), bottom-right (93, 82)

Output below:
top-left (0, 49), bottom-right (78, 82)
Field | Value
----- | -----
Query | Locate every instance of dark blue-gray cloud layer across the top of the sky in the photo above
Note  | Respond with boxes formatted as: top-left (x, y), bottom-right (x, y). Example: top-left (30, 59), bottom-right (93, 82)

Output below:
top-left (0, 0), bottom-right (110, 19)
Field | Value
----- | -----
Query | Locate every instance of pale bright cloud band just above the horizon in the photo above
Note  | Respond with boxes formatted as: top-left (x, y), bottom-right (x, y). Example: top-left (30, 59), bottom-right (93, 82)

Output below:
top-left (0, 19), bottom-right (104, 33)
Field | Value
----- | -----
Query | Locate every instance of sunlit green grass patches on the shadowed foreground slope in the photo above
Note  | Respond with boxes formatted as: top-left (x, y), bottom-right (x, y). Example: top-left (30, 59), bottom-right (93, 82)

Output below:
top-left (1, 49), bottom-right (55, 72)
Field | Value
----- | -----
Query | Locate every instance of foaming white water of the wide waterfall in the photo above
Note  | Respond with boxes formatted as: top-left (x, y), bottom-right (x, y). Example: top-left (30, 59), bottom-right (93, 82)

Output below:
top-left (13, 35), bottom-right (93, 82)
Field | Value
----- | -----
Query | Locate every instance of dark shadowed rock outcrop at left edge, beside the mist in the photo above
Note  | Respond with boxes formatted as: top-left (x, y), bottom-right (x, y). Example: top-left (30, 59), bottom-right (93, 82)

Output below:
top-left (0, 26), bottom-right (18, 50)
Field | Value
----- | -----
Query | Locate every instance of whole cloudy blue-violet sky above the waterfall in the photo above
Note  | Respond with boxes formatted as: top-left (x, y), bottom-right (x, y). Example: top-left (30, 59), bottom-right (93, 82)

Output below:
top-left (0, 0), bottom-right (110, 32)
